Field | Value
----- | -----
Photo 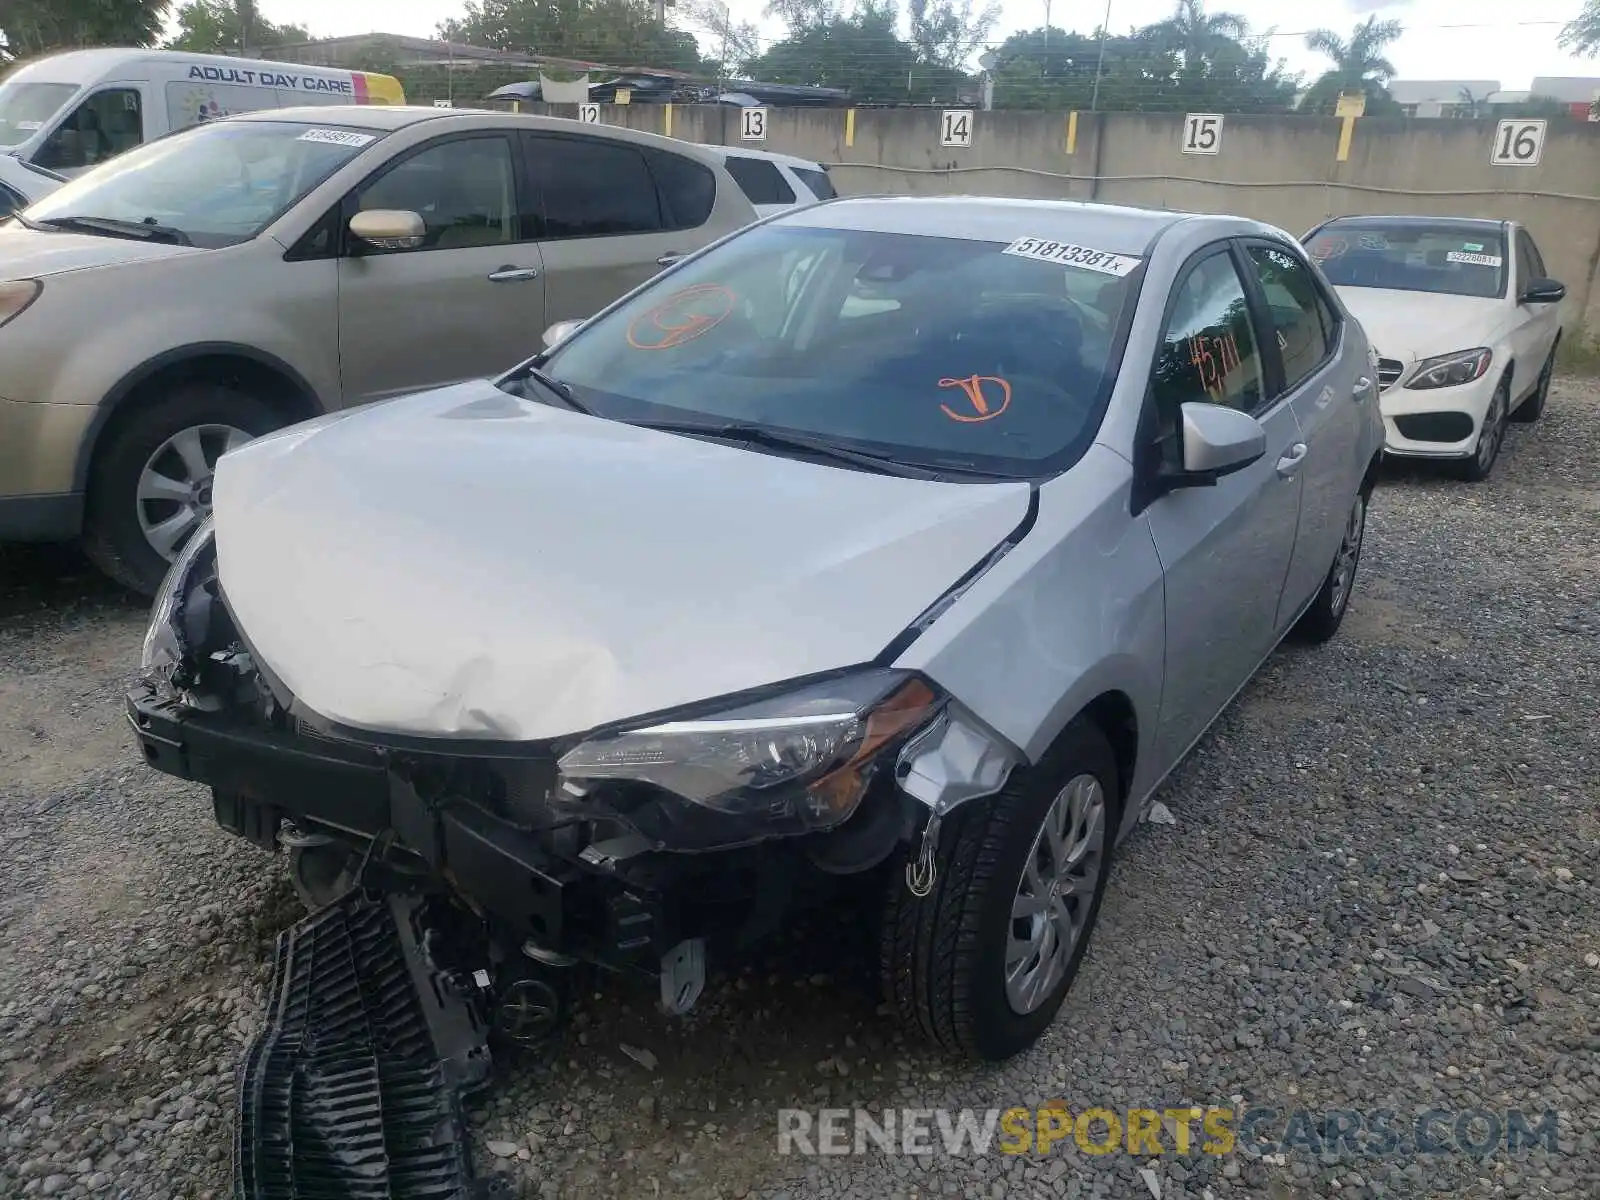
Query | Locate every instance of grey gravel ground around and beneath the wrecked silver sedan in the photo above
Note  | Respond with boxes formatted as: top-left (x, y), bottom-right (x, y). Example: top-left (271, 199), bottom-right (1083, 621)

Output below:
top-left (0, 381), bottom-right (1600, 1200)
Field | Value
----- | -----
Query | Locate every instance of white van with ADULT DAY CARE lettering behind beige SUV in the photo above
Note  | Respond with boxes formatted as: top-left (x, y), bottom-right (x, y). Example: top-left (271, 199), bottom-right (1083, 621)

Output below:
top-left (0, 50), bottom-right (405, 176)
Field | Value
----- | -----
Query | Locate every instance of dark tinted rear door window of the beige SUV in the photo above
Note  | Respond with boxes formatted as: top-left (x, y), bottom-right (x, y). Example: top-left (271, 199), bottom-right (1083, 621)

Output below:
top-left (523, 134), bottom-right (666, 238)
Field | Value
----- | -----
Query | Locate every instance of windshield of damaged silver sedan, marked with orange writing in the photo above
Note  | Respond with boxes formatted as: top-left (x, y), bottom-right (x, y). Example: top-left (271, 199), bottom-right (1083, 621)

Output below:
top-left (546, 224), bottom-right (1139, 477)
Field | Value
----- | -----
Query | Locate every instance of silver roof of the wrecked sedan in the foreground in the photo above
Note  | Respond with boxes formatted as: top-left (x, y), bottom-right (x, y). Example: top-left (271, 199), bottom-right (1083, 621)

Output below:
top-left (774, 195), bottom-right (1260, 254)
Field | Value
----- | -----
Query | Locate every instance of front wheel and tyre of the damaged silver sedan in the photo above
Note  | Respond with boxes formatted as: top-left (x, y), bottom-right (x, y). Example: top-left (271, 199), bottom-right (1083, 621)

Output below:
top-left (880, 717), bottom-right (1120, 1061)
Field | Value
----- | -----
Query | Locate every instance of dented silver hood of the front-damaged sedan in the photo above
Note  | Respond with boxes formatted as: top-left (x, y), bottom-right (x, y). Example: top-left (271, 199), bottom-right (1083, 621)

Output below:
top-left (214, 382), bottom-right (1029, 741)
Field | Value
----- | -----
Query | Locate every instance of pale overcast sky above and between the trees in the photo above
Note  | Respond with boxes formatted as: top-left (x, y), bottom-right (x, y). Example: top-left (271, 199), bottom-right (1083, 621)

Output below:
top-left (258, 0), bottom-right (1600, 88)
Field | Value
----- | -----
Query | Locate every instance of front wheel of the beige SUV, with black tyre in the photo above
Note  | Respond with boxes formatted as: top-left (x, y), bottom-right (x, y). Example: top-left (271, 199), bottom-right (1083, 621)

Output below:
top-left (83, 384), bottom-right (283, 595)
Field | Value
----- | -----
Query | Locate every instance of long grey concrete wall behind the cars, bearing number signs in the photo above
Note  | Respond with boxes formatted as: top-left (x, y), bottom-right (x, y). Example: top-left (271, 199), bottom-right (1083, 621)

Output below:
top-left (518, 104), bottom-right (1600, 334)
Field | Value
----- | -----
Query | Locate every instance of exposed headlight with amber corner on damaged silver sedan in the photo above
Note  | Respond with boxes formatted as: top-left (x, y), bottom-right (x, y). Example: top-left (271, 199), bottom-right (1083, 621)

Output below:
top-left (560, 670), bottom-right (942, 850)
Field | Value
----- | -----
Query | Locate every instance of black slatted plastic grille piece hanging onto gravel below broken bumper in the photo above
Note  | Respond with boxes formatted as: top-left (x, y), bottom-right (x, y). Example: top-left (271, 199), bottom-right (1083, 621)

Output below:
top-left (234, 891), bottom-right (501, 1200)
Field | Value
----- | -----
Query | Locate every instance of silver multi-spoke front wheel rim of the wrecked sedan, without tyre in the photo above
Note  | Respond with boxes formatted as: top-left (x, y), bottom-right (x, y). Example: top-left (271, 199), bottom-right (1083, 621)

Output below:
top-left (1005, 774), bottom-right (1106, 1016)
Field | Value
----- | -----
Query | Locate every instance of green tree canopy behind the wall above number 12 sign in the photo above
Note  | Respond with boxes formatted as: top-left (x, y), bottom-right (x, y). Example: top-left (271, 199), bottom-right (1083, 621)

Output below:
top-left (438, 0), bottom-right (702, 72)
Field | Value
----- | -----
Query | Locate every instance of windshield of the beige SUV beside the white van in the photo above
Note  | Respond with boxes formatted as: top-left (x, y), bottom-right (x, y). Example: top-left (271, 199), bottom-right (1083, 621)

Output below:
top-left (26, 122), bottom-right (378, 248)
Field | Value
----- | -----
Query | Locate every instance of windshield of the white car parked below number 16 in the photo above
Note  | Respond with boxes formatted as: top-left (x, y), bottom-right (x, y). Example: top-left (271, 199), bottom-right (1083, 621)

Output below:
top-left (1306, 224), bottom-right (1506, 296)
